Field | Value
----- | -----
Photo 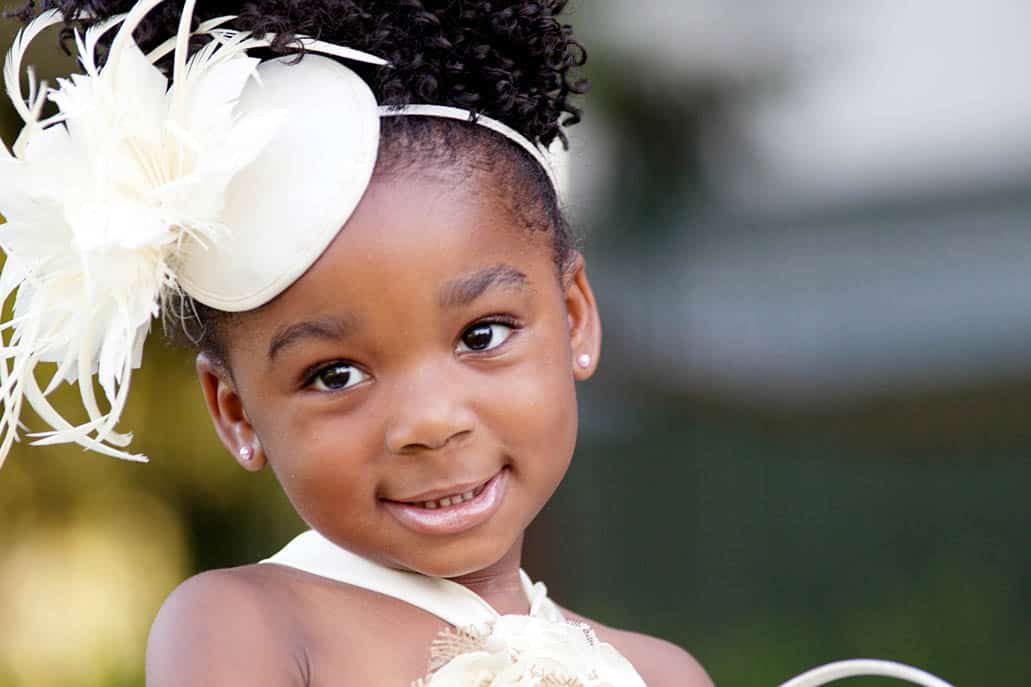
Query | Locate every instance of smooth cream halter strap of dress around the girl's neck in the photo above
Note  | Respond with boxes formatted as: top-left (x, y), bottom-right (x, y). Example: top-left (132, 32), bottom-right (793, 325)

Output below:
top-left (261, 530), bottom-right (563, 627)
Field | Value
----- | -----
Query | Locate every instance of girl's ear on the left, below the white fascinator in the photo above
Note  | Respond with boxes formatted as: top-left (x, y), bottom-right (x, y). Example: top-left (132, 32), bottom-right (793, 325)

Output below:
top-left (197, 353), bottom-right (265, 472)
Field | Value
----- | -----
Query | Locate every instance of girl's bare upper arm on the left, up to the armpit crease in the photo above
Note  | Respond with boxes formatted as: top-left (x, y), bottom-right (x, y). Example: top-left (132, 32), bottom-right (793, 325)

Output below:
top-left (146, 570), bottom-right (304, 687)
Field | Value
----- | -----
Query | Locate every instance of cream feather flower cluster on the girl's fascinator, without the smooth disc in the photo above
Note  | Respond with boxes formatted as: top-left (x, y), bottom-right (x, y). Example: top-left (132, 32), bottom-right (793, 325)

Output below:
top-left (0, 0), bottom-right (284, 465)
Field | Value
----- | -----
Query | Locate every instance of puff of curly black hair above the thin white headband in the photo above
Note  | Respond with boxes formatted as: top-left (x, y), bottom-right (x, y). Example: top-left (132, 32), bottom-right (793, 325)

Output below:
top-left (19, 0), bottom-right (587, 146)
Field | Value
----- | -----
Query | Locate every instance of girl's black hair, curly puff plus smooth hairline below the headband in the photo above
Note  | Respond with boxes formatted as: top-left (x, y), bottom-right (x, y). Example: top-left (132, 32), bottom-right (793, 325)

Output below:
top-left (15, 0), bottom-right (588, 360)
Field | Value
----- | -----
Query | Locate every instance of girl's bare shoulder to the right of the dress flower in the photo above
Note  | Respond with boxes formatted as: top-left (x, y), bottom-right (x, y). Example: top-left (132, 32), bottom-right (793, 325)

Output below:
top-left (563, 609), bottom-right (712, 687)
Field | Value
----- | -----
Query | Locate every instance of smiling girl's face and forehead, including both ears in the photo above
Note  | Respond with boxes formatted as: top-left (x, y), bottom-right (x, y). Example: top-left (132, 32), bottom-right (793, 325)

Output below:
top-left (198, 168), bottom-right (600, 577)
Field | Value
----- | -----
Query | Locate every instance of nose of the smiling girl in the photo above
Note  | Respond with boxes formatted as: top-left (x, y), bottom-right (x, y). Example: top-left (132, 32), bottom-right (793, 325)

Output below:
top-left (386, 365), bottom-right (476, 454)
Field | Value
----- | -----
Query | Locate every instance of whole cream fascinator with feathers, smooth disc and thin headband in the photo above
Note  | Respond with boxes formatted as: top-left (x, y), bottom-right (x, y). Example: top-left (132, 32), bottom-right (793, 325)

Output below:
top-left (0, 0), bottom-right (558, 465)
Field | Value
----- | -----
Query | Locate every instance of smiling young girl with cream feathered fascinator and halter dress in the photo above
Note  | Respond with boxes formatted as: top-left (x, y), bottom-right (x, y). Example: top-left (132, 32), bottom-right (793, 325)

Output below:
top-left (3, 0), bottom-right (710, 687)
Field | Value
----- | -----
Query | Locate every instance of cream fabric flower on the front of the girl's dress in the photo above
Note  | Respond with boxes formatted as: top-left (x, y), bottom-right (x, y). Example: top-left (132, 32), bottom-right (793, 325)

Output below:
top-left (413, 616), bottom-right (644, 687)
